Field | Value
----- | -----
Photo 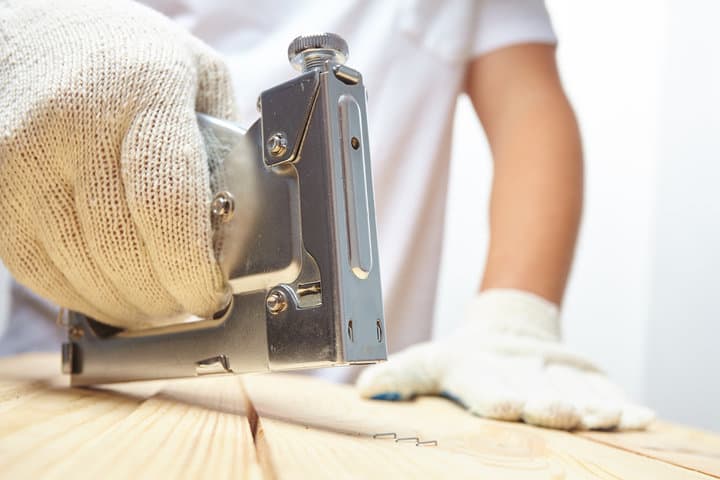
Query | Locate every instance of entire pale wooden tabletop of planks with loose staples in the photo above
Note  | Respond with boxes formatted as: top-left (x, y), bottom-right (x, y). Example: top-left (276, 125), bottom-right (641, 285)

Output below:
top-left (0, 355), bottom-right (720, 480)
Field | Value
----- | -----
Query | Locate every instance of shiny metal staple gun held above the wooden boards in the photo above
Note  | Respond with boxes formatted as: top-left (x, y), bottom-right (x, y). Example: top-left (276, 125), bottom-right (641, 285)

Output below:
top-left (63, 34), bottom-right (387, 385)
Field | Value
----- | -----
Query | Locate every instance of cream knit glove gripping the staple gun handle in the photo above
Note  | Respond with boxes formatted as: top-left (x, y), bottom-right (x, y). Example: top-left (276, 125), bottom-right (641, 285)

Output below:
top-left (0, 0), bottom-right (234, 327)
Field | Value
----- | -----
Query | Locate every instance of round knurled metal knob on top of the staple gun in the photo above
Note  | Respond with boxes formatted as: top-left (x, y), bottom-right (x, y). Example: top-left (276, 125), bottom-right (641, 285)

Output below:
top-left (288, 33), bottom-right (349, 72)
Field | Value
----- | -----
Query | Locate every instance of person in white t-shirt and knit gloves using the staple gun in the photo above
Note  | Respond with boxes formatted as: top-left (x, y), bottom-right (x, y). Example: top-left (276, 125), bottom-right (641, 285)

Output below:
top-left (0, 0), bottom-right (652, 429)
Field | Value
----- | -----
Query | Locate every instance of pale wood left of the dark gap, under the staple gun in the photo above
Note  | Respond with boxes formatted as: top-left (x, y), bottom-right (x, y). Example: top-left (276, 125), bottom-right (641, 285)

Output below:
top-left (0, 356), bottom-right (262, 479)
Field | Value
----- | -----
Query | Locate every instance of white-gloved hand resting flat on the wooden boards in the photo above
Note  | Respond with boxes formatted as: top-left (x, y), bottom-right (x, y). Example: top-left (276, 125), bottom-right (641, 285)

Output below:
top-left (357, 290), bottom-right (654, 430)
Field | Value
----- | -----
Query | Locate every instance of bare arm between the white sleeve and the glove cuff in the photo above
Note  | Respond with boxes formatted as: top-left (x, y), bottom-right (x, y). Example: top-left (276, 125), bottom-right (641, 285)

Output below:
top-left (466, 44), bottom-right (583, 304)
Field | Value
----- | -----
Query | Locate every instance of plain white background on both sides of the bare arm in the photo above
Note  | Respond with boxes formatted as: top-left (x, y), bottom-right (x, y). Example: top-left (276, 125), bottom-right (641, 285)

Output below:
top-left (436, 0), bottom-right (720, 431)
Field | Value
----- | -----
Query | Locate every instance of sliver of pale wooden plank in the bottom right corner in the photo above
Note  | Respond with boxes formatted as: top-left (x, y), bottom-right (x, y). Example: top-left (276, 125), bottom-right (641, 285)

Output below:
top-left (581, 422), bottom-right (720, 478)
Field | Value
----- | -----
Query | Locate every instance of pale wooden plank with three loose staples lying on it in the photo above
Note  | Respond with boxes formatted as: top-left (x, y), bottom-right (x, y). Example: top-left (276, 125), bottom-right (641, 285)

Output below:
top-left (243, 375), bottom-right (708, 480)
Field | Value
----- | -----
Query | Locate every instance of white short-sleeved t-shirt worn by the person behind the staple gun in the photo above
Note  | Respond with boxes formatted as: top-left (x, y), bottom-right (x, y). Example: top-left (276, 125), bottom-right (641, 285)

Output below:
top-left (0, 0), bottom-right (555, 378)
